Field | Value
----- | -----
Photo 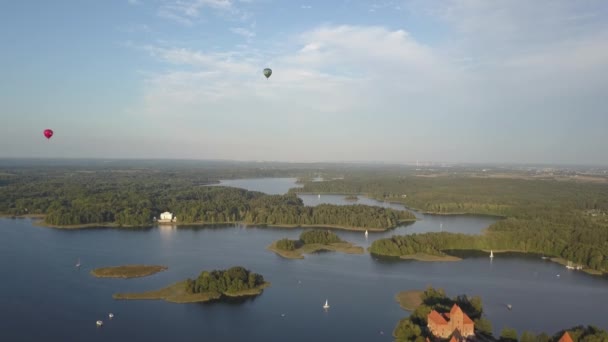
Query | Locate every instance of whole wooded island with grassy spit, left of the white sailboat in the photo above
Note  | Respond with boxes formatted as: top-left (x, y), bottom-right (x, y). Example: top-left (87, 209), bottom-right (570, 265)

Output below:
top-left (112, 266), bottom-right (270, 303)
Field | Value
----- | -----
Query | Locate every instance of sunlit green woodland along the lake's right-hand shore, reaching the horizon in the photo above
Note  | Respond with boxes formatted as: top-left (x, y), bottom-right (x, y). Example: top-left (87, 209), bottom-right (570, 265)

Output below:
top-left (292, 176), bottom-right (608, 271)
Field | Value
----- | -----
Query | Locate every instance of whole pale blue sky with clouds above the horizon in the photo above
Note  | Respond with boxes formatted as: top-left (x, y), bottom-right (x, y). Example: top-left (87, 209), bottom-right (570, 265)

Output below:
top-left (0, 0), bottom-right (608, 164)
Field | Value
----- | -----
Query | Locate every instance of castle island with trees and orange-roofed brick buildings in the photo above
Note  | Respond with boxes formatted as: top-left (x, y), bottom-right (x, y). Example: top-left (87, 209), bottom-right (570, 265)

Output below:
top-left (393, 286), bottom-right (608, 342)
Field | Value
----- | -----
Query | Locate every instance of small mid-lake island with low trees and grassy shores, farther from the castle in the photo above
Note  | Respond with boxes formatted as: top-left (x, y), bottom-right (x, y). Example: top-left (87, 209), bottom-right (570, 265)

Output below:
top-left (267, 230), bottom-right (364, 259)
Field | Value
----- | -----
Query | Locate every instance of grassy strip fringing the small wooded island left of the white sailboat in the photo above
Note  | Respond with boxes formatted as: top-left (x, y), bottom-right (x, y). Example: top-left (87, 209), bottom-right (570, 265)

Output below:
top-left (112, 280), bottom-right (270, 304)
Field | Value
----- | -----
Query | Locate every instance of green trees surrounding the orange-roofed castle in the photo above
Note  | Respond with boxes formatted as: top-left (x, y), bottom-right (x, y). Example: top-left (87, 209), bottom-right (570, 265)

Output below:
top-left (393, 286), bottom-right (608, 342)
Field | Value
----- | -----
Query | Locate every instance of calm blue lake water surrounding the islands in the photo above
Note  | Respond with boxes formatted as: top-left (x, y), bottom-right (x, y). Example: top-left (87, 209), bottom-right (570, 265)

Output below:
top-left (0, 179), bottom-right (608, 342)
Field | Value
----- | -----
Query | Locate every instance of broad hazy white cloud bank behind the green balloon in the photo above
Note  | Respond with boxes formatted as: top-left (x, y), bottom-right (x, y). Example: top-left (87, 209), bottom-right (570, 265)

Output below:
top-left (127, 0), bottom-right (608, 161)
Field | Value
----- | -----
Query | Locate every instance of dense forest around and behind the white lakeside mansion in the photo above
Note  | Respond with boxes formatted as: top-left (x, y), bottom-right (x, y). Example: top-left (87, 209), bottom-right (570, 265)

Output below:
top-left (0, 168), bottom-right (415, 228)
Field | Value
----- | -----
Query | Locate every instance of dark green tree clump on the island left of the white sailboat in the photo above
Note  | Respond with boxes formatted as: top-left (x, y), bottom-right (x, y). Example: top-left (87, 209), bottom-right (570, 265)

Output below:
top-left (186, 266), bottom-right (265, 294)
